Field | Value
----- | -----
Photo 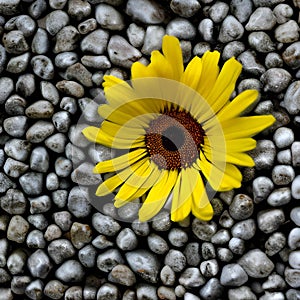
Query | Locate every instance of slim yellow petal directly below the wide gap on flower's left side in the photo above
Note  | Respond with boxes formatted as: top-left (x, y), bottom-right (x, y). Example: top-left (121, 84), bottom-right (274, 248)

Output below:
top-left (94, 148), bottom-right (147, 173)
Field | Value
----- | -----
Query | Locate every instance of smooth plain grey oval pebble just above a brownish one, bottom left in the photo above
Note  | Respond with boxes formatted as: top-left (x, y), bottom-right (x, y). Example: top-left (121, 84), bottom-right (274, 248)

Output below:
top-left (55, 260), bottom-right (85, 283)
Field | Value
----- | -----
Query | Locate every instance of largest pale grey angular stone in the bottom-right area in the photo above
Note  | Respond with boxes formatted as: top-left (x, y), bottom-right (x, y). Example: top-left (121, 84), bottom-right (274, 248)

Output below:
top-left (238, 249), bottom-right (274, 278)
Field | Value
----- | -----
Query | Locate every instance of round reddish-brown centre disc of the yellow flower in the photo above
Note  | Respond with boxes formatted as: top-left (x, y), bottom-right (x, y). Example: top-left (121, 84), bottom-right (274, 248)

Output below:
top-left (146, 109), bottom-right (205, 170)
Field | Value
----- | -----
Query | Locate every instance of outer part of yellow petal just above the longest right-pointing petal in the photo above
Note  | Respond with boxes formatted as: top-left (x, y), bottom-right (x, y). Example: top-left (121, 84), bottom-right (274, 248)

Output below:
top-left (218, 90), bottom-right (258, 121)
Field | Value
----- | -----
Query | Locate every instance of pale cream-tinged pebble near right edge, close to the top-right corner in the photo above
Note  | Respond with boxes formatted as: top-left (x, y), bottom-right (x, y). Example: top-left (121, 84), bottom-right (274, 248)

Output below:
top-left (275, 20), bottom-right (300, 43)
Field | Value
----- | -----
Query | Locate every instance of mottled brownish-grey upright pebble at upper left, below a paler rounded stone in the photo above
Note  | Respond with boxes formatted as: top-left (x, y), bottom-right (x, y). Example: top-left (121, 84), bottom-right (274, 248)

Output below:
top-left (53, 26), bottom-right (80, 53)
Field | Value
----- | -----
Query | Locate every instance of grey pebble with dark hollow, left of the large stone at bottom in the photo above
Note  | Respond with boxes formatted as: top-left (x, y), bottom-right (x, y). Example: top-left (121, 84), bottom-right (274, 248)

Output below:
top-left (97, 249), bottom-right (123, 273)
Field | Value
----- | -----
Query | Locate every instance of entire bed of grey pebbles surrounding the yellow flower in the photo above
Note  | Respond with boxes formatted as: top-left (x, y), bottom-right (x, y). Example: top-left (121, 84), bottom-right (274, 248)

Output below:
top-left (0, 0), bottom-right (300, 300)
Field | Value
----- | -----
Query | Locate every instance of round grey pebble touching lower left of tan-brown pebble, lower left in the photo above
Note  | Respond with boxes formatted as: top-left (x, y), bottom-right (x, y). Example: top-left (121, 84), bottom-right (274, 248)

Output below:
top-left (48, 239), bottom-right (75, 264)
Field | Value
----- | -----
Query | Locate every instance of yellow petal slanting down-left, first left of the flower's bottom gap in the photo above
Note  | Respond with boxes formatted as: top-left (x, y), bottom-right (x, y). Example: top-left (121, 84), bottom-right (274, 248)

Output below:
top-left (139, 170), bottom-right (178, 222)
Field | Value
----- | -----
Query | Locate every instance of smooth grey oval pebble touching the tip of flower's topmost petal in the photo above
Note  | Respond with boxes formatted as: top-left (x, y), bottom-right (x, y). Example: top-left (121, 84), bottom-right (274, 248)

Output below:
top-left (166, 18), bottom-right (196, 40)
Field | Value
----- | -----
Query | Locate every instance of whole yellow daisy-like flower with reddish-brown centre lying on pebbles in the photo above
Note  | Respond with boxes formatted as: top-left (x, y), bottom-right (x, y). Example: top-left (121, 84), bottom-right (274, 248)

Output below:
top-left (83, 36), bottom-right (275, 222)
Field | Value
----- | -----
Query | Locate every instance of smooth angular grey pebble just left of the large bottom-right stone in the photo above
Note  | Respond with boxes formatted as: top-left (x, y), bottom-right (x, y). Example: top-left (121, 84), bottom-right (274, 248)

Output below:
top-left (220, 264), bottom-right (248, 286)
